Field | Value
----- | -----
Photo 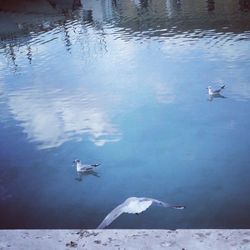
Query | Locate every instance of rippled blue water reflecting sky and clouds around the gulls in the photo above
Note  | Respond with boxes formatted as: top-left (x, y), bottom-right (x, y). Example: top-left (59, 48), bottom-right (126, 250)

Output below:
top-left (0, 0), bottom-right (250, 229)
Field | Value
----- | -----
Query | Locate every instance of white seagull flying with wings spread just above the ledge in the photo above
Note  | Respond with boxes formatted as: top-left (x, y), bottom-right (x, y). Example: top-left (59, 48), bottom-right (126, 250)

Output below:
top-left (97, 197), bottom-right (185, 229)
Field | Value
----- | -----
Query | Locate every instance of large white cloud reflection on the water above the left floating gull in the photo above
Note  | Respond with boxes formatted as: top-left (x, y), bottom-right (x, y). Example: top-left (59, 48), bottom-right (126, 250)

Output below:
top-left (8, 89), bottom-right (121, 149)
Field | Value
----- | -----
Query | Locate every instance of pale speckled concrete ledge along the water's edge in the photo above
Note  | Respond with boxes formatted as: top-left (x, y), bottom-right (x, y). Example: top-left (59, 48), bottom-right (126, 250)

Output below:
top-left (0, 230), bottom-right (250, 250)
